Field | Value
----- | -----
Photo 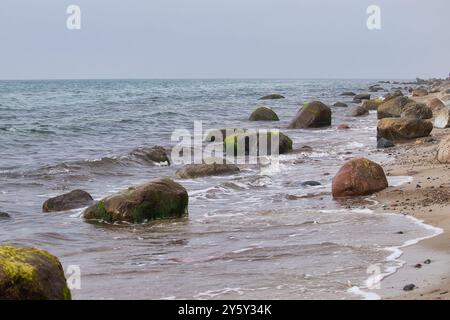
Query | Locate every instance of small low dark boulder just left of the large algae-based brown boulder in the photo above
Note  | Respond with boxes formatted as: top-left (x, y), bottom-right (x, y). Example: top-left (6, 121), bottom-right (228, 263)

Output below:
top-left (42, 190), bottom-right (93, 212)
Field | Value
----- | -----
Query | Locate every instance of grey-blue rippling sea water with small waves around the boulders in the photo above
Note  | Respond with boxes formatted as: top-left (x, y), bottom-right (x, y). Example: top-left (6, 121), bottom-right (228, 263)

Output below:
top-left (0, 80), bottom-right (432, 299)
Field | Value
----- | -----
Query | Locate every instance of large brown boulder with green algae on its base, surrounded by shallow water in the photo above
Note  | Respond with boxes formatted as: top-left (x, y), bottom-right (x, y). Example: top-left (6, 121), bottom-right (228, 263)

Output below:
top-left (83, 178), bottom-right (189, 223)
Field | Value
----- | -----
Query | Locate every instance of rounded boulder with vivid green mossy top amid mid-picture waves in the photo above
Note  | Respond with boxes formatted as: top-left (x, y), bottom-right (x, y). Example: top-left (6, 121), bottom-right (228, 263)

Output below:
top-left (224, 130), bottom-right (293, 156)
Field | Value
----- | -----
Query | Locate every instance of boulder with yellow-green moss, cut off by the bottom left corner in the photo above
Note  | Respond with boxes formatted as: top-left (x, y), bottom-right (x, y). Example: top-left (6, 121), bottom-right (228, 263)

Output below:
top-left (0, 246), bottom-right (71, 300)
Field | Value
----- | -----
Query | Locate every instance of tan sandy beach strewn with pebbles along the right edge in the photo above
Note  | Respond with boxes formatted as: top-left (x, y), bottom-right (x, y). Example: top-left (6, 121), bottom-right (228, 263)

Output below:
top-left (376, 84), bottom-right (450, 299)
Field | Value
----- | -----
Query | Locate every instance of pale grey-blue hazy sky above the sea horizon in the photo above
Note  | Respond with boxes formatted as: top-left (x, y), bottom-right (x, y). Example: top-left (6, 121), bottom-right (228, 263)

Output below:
top-left (0, 0), bottom-right (450, 79)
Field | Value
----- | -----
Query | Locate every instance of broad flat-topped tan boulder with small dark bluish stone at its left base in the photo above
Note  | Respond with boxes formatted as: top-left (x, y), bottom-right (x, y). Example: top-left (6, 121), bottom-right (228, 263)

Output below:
top-left (377, 118), bottom-right (433, 140)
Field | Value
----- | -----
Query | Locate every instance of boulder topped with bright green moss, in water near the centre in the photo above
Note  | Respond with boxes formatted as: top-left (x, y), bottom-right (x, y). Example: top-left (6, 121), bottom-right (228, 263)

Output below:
top-left (224, 130), bottom-right (293, 156)
